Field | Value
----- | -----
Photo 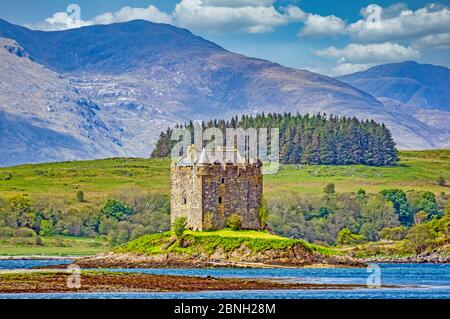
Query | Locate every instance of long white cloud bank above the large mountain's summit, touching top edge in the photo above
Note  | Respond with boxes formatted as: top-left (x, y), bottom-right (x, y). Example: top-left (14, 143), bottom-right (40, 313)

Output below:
top-left (27, 0), bottom-right (306, 33)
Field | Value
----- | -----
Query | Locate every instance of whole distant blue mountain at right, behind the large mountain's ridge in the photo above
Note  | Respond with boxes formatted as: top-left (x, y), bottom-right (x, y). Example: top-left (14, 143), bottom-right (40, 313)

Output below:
top-left (338, 61), bottom-right (450, 148)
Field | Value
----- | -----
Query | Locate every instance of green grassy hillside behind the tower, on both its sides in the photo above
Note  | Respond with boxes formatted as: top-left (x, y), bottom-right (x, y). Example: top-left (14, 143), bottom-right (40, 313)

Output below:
top-left (0, 150), bottom-right (450, 206)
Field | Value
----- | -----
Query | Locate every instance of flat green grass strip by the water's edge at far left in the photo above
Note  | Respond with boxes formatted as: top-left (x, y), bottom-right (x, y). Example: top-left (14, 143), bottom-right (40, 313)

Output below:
top-left (0, 236), bottom-right (108, 256)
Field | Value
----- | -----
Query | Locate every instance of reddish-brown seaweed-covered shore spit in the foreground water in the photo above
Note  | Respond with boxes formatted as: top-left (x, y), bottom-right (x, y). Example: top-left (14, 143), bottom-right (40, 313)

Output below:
top-left (0, 270), bottom-right (395, 294)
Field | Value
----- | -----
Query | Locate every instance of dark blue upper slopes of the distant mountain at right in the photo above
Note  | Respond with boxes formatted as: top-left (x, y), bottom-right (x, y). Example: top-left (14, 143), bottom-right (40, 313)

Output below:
top-left (338, 61), bottom-right (450, 112)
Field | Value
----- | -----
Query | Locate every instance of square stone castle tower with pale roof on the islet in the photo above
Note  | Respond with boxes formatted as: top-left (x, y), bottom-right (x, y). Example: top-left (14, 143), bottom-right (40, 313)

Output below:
top-left (170, 145), bottom-right (263, 231)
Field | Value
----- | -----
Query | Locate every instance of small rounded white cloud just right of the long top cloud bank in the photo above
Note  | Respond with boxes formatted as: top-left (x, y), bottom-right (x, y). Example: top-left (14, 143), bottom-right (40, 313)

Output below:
top-left (299, 14), bottom-right (346, 37)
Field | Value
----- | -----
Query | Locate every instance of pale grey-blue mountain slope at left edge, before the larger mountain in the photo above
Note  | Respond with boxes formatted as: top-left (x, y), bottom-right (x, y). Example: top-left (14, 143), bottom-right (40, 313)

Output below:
top-left (0, 39), bottom-right (120, 166)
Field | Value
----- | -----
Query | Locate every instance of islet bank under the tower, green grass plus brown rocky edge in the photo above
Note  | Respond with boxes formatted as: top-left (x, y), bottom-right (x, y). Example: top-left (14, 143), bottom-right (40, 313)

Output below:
top-left (66, 230), bottom-right (362, 268)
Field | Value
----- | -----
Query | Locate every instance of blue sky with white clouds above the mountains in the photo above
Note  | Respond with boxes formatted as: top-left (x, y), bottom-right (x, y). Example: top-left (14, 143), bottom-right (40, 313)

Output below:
top-left (0, 0), bottom-right (450, 76)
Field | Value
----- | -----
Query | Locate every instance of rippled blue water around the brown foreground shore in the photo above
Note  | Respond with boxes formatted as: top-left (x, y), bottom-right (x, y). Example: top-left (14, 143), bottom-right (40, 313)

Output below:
top-left (0, 260), bottom-right (450, 299)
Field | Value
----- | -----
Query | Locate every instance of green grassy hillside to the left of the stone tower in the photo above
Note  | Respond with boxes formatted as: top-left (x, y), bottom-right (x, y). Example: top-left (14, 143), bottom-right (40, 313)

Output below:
top-left (0, 158), bottom-right (170, 205)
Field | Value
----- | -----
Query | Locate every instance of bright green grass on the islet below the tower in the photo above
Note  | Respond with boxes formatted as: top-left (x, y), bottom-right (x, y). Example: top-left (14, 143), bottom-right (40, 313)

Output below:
top-left (115, 229), bottom-right (337, 255)
